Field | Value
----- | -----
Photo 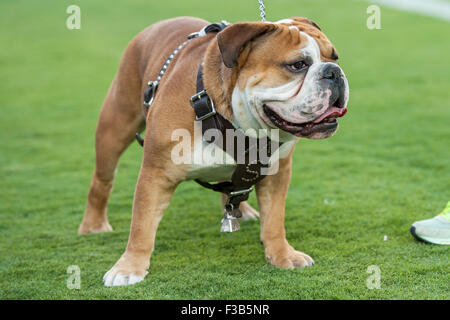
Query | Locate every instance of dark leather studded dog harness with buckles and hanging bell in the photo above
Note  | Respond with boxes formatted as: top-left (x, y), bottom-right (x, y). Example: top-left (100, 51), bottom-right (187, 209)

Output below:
top-left (136, 22), bottom-right (279, 232)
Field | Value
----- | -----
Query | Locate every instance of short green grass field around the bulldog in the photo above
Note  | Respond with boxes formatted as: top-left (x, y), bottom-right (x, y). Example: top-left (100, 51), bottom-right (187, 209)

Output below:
top-left (0, 0), bottom-right (450, 299)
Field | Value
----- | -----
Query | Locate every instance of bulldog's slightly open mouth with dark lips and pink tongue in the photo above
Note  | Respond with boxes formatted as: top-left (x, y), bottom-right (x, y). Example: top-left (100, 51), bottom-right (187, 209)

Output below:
top-left (263, 104), bottom-right (347, 137)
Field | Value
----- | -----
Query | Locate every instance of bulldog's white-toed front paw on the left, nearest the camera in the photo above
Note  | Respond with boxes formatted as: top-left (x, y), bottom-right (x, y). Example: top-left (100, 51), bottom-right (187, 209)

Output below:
top-left (103, 254), bottom-right (148, 287)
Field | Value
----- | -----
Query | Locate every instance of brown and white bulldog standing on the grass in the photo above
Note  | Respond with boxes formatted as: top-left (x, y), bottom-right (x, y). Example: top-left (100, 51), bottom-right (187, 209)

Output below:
top-left (78, 17), bottom-right (349, 286)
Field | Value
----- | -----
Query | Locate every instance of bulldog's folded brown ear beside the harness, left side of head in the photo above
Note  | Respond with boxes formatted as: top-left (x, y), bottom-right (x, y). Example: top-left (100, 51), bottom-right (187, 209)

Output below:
top-left (217, 22), bottom-right (276, 68)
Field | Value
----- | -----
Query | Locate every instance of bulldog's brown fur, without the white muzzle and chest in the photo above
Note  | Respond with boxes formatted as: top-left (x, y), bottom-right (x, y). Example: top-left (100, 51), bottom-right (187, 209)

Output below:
top-left (78, 18), bottom-right (337, 284)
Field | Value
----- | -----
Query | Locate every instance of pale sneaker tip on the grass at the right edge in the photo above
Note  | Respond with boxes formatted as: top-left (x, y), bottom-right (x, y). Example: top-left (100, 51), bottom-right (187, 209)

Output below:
top-left (409, 201), bottom-right (450, 245)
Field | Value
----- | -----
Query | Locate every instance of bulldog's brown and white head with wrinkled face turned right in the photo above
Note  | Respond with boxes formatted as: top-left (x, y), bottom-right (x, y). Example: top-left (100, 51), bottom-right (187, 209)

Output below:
top-left (218, 18), bottom-right (349, 141)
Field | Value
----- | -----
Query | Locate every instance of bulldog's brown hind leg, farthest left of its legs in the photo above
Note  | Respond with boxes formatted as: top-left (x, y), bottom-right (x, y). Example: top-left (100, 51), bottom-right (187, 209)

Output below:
top-left (78, 44), bottom-right (145, 234)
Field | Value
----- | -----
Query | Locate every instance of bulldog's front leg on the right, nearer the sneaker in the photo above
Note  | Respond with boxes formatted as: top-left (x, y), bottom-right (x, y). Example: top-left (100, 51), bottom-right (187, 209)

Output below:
top-left (256, 156), bottom-right (314, 268)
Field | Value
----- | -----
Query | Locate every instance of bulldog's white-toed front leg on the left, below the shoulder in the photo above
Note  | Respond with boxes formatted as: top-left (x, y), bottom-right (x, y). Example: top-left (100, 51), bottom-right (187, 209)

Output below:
top-left (103, 166), bottom-right (177, 286)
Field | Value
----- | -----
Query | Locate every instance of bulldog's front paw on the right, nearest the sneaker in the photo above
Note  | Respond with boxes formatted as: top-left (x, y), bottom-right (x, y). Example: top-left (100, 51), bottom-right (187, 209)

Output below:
top-left (266, 246), bottom-right (314, 269)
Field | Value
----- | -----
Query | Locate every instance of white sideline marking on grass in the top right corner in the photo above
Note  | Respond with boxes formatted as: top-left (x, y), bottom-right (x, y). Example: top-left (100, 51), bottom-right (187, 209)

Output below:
top-left (370, 0), bottom-right (450, 21)
